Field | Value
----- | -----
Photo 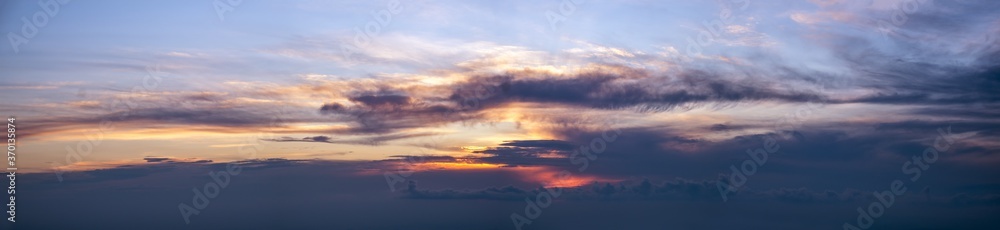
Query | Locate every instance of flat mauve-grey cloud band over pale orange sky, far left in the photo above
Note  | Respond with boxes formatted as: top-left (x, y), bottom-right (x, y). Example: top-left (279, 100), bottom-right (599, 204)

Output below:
top-left (22, 94), bottom-right (300, 137)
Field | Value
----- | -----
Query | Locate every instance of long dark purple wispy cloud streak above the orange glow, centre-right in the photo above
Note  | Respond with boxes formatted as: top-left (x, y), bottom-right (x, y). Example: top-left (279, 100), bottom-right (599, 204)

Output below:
top-left (456, 69), bottom-right (823, 111)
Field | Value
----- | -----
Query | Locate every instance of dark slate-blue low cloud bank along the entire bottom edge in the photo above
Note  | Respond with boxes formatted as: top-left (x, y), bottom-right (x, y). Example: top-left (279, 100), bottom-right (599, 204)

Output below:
top-left (17, 157), bottom-right (998, 229)
